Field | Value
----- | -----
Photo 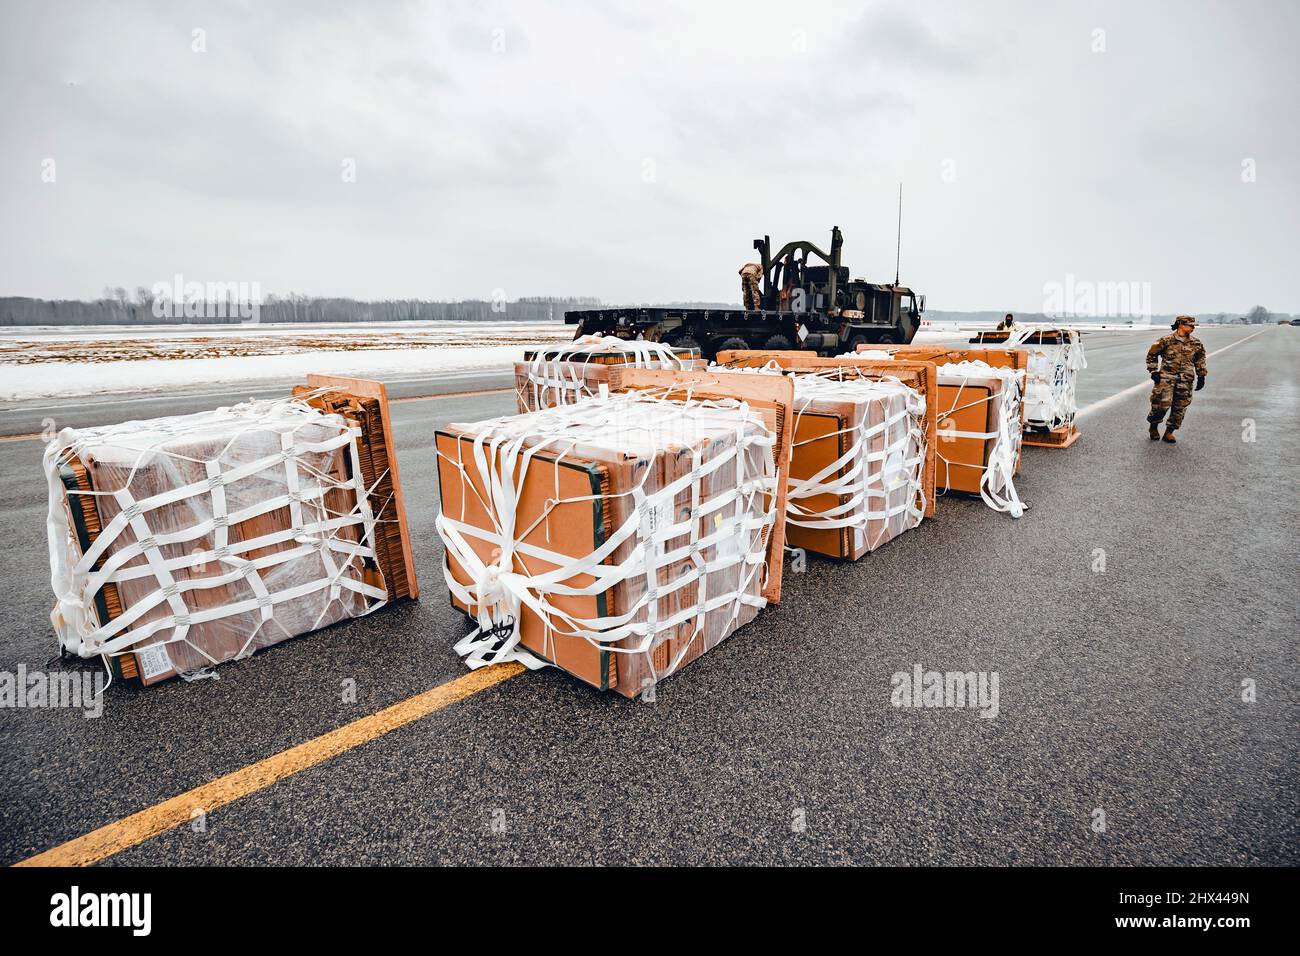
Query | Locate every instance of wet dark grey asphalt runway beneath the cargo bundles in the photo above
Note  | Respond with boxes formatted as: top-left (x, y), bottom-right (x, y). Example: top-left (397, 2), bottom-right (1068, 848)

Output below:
top-left (0, 326), bottom-right (1300, 865)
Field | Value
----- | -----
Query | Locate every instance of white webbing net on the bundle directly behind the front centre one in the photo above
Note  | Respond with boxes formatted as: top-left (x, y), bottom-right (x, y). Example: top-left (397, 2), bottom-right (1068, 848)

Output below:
top-left (785, 369), bottom-right (927, 549)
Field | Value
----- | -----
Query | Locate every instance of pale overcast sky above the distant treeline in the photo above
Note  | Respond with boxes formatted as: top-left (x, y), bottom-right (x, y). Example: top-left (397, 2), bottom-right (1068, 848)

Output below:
top-left (0, 0), bottom-right (1300, 313)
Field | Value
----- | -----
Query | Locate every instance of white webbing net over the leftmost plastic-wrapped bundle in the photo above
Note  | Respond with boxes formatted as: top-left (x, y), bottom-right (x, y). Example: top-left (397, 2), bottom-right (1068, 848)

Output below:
top-left (44, 401), bottom-right (391, 671)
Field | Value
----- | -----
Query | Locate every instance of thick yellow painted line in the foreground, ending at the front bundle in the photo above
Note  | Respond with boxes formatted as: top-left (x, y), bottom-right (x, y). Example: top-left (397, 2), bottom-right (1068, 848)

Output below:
top-left (14, 663), bottom-right (524, 866)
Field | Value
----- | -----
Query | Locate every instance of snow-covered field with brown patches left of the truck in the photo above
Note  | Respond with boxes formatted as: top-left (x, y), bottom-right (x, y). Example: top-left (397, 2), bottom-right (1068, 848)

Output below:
top-left (0, 323), bottom-right (573, 402)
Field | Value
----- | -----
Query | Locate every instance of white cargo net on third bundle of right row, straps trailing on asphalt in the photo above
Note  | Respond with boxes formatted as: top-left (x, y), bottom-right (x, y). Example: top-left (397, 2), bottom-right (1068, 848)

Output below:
top-left (935, 362), bottom-right (1026, 518)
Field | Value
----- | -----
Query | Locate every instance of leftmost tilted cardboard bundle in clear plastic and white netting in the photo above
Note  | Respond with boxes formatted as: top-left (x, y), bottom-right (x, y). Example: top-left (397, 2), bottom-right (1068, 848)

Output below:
top-left (46, 380), bottom-right (417, 685)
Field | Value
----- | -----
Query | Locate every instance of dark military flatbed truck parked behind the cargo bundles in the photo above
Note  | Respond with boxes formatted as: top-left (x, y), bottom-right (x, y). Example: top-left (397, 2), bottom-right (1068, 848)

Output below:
top-left (564, 226), bottom-right (926, 359)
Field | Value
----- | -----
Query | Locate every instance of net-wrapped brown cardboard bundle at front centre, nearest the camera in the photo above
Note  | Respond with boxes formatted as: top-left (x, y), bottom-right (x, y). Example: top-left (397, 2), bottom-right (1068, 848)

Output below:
top-left (436, 394), bottom-right (779, 697)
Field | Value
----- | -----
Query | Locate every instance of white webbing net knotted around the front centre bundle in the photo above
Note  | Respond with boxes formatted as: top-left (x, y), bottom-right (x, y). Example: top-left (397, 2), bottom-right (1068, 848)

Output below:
top-left (436, 386), bottom-right (776, 680)
